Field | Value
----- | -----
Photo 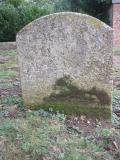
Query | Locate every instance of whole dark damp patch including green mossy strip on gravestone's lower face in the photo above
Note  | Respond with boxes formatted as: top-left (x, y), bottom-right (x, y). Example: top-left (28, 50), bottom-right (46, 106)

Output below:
top-left (28, 76), bottom-right (111, 119)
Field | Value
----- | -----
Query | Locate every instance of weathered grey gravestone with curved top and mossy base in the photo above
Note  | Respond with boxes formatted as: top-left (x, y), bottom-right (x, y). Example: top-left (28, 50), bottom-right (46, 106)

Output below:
top-left (17, 12), bottom-right (112, 119)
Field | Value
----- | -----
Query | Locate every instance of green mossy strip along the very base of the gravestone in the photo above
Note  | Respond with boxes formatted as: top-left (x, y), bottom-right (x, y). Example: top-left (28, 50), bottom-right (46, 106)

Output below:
top-left (30, 100), bottom-right (111, 119)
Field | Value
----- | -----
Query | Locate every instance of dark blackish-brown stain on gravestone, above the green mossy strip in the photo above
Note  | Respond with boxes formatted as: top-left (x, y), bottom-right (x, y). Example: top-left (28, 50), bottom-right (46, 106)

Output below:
top-left (44, 76), bottom-right (111, 106)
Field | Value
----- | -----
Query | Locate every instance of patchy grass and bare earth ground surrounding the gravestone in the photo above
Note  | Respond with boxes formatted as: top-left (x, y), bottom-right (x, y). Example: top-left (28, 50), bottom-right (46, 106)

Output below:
top-left (0, 47), bottom-right (120, 160)
